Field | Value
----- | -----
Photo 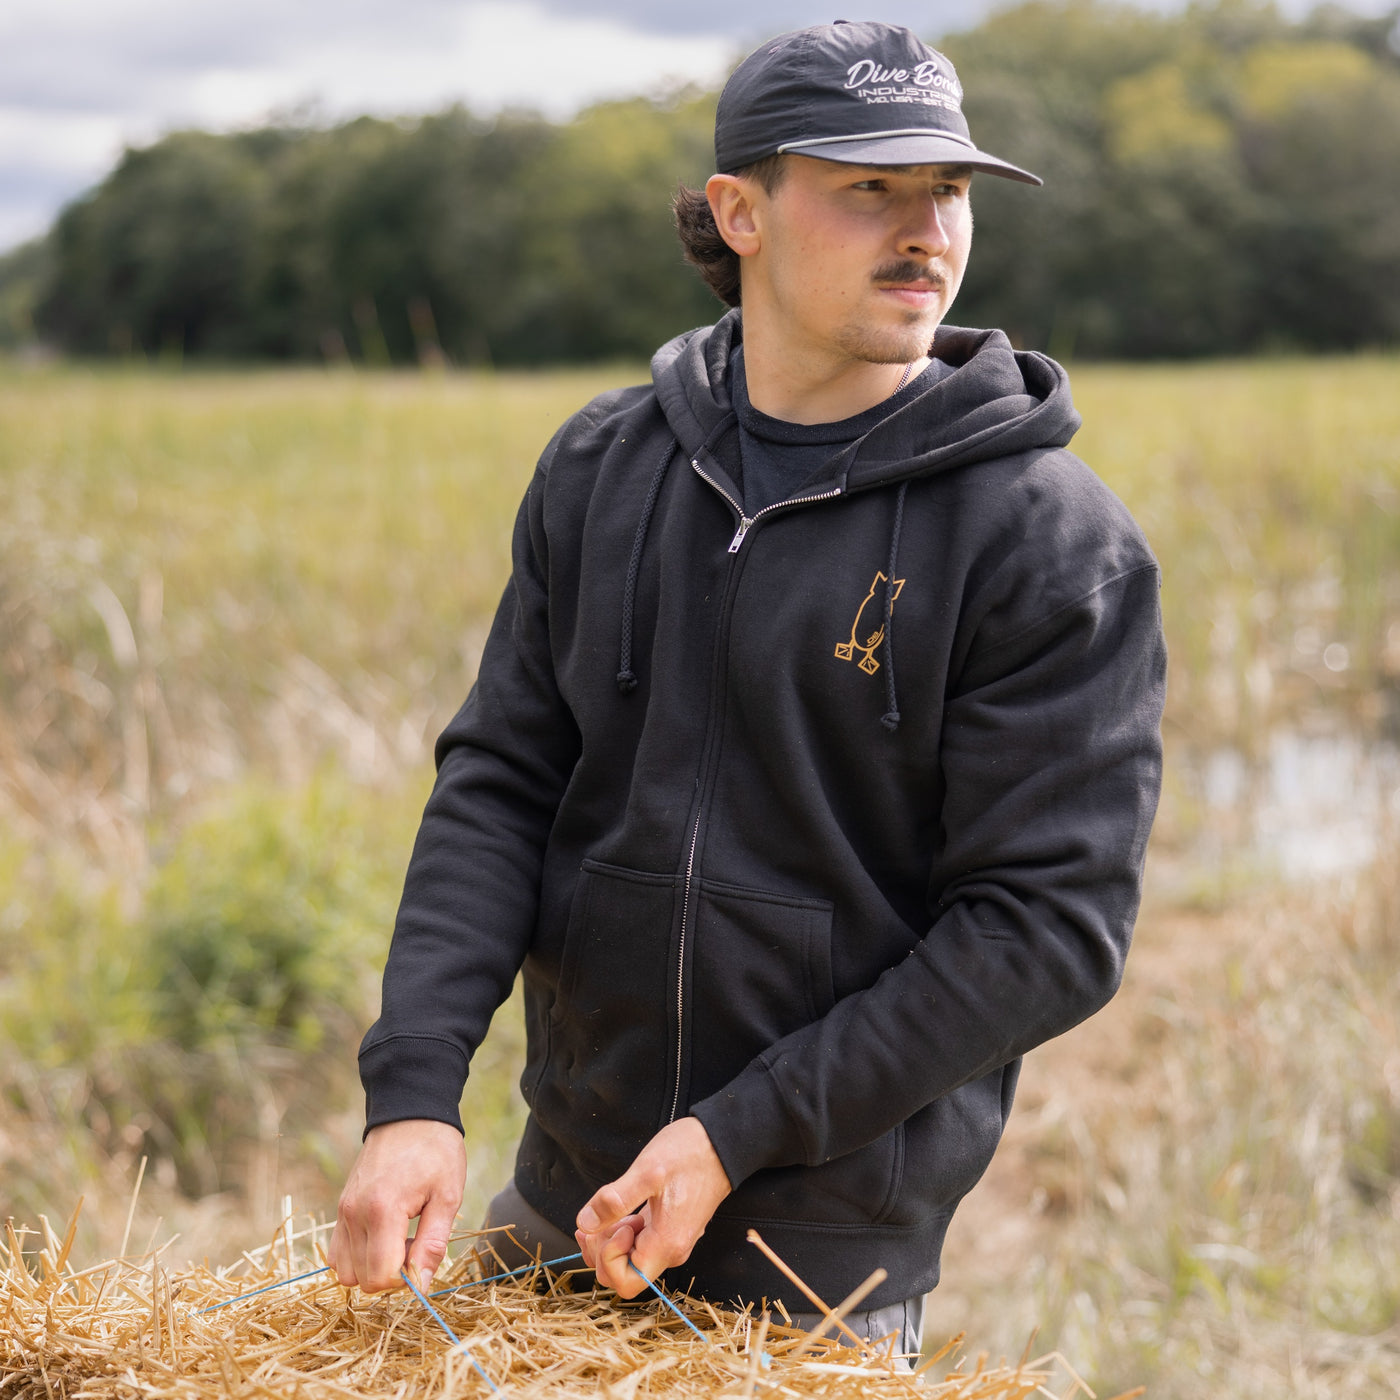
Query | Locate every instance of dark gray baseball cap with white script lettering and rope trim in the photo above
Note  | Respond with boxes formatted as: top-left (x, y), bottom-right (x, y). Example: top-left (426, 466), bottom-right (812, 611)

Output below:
top-left (714, 20), bottom-right (1042, 185)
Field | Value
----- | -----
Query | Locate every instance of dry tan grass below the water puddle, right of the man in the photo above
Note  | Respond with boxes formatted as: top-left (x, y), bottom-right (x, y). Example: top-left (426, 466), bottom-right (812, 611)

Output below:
top-left (928, 858), bottom-right (1400, 1400)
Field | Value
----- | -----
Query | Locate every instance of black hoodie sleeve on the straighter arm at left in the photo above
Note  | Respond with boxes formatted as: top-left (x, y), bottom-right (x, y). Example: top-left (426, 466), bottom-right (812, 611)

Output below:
top-left (360, 450), bottom-right (580, 1131)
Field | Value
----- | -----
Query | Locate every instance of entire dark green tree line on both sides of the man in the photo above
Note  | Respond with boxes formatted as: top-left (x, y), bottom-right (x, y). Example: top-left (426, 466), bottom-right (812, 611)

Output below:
top-left (0, 0), bottom-right (1400, 365)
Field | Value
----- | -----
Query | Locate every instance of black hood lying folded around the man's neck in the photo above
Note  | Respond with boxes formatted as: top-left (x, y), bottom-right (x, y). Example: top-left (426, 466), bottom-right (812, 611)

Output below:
top-left (651, 309), bottom-right (1079, 491)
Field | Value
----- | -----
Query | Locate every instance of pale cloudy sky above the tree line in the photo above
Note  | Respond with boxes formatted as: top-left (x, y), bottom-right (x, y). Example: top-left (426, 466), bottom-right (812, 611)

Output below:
top-left (0, 0), bottom-right (1383, 251)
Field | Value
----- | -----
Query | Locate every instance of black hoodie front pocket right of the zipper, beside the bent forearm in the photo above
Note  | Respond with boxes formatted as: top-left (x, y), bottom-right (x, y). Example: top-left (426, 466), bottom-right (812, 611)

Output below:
top-left (682, 881), bottom-right (834, 1103)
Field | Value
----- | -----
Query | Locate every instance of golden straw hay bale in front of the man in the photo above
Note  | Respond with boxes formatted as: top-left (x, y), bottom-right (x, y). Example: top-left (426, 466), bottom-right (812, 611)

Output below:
top-left (0, 1214), bottom-right (1114, 1400)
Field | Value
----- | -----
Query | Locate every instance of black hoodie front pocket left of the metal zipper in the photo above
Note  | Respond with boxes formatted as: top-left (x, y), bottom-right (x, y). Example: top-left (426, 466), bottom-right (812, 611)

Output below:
top-left (531, 861), bottom-right (676, 1176)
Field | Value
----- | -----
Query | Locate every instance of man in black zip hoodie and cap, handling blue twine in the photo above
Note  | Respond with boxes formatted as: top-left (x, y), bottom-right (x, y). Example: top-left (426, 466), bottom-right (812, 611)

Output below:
top-left (324, 24), bottom-right (1165, 1348)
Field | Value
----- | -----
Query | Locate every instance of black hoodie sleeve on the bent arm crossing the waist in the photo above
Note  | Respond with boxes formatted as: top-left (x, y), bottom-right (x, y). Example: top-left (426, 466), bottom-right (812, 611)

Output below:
top-left (692, 546), bottom-right (1166, 1184)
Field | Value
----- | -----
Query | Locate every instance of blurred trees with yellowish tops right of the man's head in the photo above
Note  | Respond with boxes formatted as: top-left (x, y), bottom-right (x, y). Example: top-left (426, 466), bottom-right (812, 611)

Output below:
top-left (946, 0), bottom-right (1400, 357)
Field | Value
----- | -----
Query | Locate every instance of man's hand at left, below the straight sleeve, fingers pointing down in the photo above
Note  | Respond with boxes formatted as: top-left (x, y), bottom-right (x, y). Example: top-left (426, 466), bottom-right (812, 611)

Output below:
top-left (328, 1119), bottom-right (466, 1294)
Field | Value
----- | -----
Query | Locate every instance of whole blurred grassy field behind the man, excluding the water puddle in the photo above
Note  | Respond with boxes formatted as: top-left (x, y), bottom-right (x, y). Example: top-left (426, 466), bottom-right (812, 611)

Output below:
top-left (0, 357), bottom-right (1400, 1397)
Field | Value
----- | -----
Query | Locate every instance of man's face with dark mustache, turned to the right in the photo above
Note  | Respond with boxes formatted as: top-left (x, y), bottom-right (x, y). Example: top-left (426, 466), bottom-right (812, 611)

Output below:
top-left (743, 155), bottom-right (972, 364)
